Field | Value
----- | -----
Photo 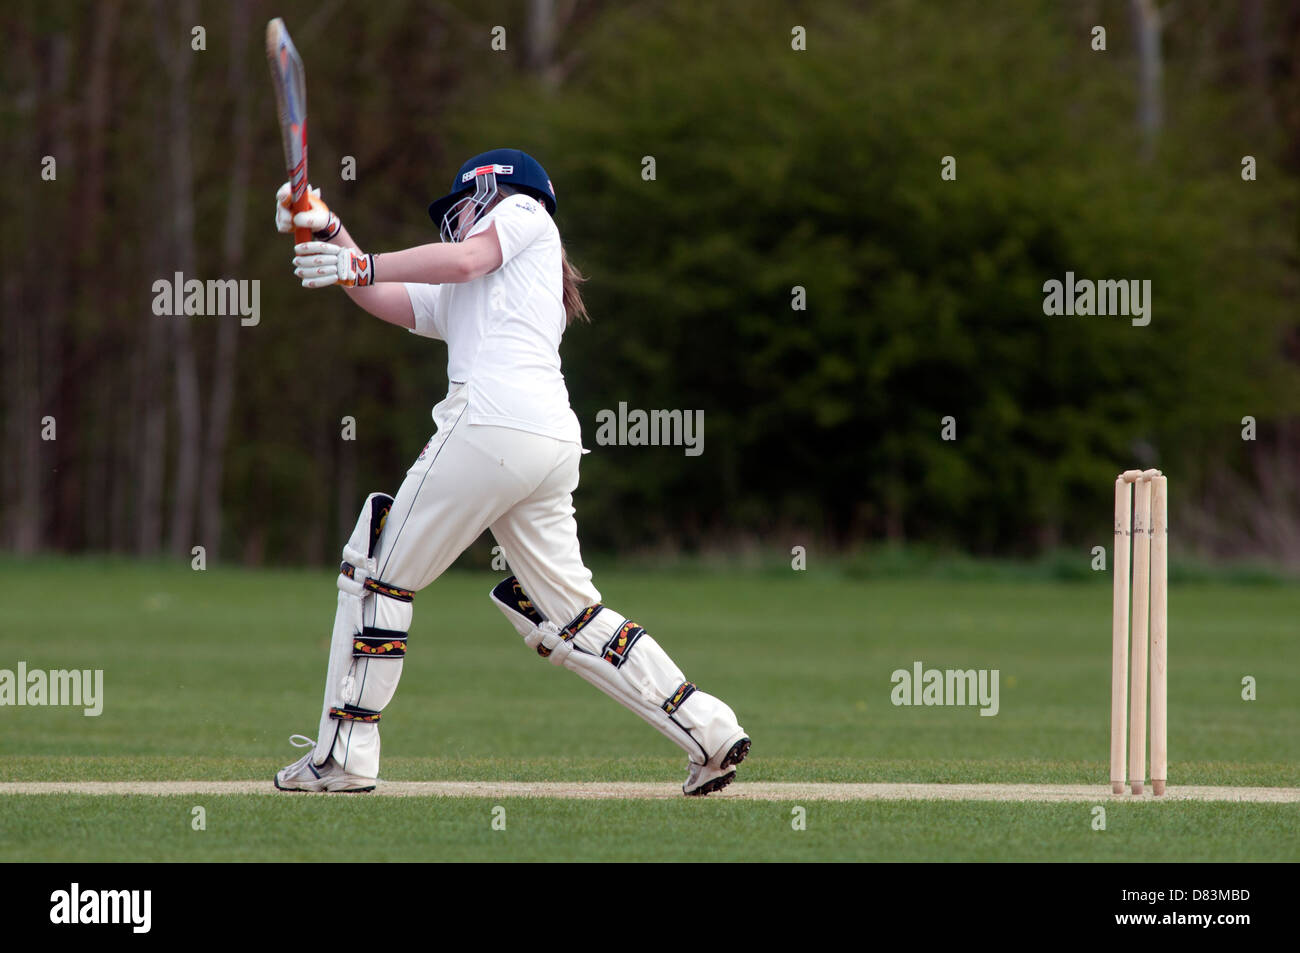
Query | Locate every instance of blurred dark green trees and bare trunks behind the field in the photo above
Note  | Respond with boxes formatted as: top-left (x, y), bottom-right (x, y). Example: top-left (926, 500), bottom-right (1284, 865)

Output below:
top-left (0, 0), bottom-right (1300, 564)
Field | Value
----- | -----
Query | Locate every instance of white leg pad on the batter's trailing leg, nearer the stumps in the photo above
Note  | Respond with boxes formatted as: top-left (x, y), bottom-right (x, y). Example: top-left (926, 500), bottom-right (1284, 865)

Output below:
top-left (491, 577), bottom-right (740, 764)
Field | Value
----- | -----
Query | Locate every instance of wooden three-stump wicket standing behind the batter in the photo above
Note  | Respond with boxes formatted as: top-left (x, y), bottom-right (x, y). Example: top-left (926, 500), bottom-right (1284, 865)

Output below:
top-left (1110, 469), bottom-right (1169, 796)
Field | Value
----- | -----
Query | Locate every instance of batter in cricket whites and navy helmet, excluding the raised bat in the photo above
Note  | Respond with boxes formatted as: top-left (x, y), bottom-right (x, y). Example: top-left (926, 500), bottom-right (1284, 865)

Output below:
top-left (276, 150), bottom-right (750, 794)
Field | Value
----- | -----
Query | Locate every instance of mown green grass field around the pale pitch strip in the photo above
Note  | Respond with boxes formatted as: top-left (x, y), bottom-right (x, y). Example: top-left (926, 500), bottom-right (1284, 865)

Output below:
top-left (0, 559), bottom-right (1300, 861)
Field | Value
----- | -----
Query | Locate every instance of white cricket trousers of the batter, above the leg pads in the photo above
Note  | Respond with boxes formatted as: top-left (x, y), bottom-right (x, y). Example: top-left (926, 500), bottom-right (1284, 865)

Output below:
top-left (377, 385), bottom-right (601, 624)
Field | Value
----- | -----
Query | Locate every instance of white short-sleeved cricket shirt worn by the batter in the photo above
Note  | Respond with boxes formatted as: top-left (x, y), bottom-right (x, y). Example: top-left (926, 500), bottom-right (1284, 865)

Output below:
top-left (406, 195), bottom-right (582, 443)
